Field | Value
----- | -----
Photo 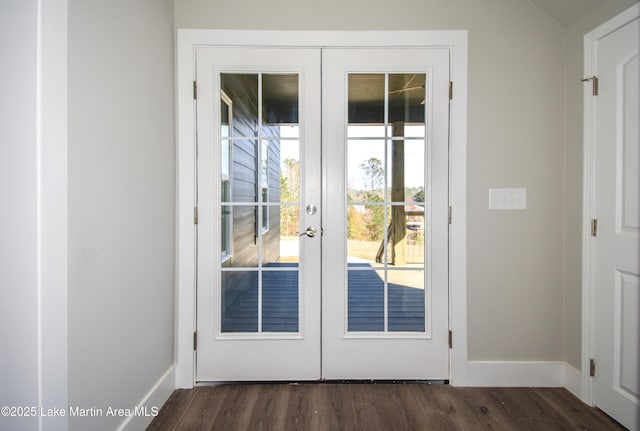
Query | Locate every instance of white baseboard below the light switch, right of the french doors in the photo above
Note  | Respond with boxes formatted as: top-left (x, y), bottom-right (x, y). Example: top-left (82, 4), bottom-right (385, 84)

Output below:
top-left (452, 361), bottom-right (581, 392)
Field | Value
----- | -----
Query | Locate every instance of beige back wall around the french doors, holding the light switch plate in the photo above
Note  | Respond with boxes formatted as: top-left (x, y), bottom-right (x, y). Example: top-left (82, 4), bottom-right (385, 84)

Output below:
top-left (174, 0), bottom-right (566, 361)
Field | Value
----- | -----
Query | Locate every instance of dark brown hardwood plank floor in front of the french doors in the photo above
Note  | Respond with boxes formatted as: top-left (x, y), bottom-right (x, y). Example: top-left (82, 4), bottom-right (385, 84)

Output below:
top-left (147, 383), bottom-right (624, 431)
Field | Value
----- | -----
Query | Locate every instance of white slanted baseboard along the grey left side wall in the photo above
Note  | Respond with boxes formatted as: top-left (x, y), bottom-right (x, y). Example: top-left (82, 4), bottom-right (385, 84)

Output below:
top-left (118, 365), bottom-right (176, 431)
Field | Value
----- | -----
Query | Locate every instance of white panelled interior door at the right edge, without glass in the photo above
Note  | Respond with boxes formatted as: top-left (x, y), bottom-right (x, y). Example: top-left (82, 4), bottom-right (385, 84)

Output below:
top-left (593, 11), bottom-right (640, 430)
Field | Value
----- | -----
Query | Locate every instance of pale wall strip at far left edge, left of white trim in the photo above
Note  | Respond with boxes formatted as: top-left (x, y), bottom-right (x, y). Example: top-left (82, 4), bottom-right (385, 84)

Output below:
top-left (0, 0), bottom-right (39, 430)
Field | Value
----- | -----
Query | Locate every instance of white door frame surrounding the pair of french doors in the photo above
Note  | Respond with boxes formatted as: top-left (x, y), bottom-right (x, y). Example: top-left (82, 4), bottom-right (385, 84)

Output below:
top-left (175, 29), bottom-right (468, 388)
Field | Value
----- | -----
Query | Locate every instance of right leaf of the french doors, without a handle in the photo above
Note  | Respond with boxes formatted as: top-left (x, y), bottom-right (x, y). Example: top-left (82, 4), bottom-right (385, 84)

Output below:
top-left (322, 49), bottom-right (449, 379)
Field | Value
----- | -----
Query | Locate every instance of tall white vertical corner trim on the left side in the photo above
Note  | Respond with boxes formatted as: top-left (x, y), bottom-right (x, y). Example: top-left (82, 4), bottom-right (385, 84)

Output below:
top-left (37, 0), bottom-right (69, 429)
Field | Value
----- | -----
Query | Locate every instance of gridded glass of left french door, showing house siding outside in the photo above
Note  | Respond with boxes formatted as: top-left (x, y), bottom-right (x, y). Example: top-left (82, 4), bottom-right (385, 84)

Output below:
top-left (219, 73), bottom-right (300, 334)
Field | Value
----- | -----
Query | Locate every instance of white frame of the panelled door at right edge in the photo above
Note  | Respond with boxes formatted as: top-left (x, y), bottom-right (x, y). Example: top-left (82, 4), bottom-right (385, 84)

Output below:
top-left (581, 4), bottom-right (640, 405)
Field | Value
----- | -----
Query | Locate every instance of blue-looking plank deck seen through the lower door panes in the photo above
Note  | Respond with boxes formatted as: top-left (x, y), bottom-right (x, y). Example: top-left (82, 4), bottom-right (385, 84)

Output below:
top-left (222, 264), bottom-right (425, 332)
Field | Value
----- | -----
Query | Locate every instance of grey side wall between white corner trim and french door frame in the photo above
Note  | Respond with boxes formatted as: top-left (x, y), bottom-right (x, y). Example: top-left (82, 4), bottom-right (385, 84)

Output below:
top-left (69, 0), bottom-right (175, 430)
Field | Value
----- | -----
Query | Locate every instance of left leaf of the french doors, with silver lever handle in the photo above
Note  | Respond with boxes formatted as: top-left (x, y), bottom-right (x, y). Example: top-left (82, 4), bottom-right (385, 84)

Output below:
top-left (196, 47), bottom-right (321, 381)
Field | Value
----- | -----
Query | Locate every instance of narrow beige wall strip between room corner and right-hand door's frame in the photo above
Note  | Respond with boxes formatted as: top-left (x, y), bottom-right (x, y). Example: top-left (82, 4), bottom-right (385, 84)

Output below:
top-left (563, 0), bottom-right (637, 368)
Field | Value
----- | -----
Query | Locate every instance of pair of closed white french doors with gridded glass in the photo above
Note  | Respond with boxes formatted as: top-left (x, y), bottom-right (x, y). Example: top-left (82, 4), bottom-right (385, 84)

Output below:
top-left (196, 47), bottom-right (449, 381)
